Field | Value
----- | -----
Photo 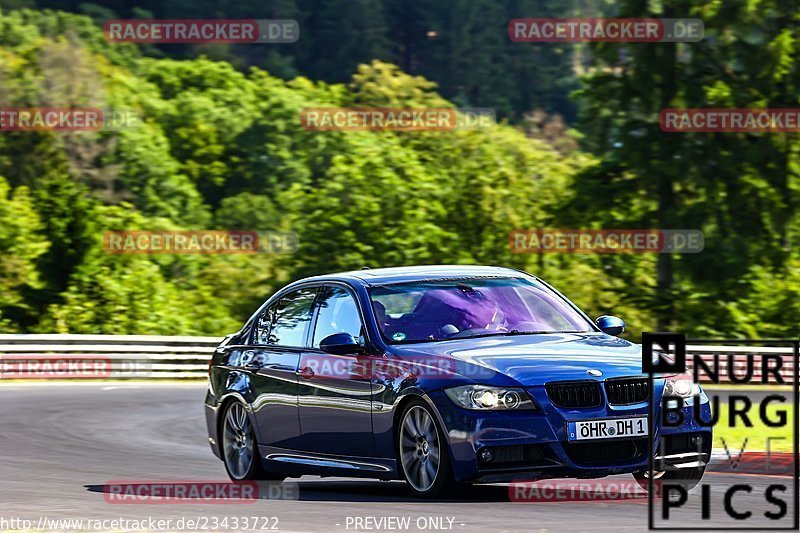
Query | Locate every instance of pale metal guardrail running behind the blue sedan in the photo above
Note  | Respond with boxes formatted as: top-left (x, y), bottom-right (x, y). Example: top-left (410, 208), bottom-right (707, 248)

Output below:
top-left (0, 334), bottom-right (794, 383)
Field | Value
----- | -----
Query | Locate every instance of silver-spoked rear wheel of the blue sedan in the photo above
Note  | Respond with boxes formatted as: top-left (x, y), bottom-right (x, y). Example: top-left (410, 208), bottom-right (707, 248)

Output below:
top-left (222, 401), bottom-right (286, 481)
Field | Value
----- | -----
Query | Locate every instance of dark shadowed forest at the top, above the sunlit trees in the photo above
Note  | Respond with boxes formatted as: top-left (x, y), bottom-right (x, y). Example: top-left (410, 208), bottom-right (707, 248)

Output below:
top-left (0, 0), bottom-right (588, 120)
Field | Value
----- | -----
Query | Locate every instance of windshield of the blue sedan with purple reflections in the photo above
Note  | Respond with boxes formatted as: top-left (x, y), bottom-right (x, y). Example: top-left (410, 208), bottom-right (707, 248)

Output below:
top-left (370, 278), bottom-right (594, 344)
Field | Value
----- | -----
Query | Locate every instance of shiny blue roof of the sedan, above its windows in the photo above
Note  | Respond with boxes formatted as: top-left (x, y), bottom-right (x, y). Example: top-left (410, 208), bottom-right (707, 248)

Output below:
top-left (301, 265), bottom-right (528, 286)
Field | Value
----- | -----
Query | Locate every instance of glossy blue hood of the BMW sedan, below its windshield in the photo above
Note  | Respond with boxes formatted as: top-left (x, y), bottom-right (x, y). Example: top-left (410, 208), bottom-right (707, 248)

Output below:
top-left (394, 333), bottom-right (642, 386)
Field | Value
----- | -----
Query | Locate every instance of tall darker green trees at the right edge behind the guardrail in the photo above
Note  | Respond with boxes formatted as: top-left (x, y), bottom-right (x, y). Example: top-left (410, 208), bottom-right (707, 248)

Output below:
top-left (572, 0), bottom-right (798, 334)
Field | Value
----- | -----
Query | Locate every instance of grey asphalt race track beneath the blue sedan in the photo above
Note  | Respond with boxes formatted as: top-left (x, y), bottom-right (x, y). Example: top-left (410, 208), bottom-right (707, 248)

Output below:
top-left (0, 382), bottom-right (794, 532)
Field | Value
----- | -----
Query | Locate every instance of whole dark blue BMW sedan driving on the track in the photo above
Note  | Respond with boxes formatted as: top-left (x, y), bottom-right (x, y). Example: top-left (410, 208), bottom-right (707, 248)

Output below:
top-left (205, 266), bottom-right (711, 497)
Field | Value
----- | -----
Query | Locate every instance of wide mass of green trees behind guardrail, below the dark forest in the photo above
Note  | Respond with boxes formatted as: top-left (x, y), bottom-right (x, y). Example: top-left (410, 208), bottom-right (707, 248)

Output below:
top-left (0, 1), bottom-right (800, 336)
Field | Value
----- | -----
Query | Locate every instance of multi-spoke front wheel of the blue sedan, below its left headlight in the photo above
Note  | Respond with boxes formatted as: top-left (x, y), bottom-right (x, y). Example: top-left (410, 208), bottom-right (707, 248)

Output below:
top-left (397, 400), bottom-right (455, 498)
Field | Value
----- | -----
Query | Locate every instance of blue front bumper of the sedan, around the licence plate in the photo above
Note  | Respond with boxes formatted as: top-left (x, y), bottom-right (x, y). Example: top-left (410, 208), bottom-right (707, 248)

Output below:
top-left (428, 387), bottom-right (711, 483)
